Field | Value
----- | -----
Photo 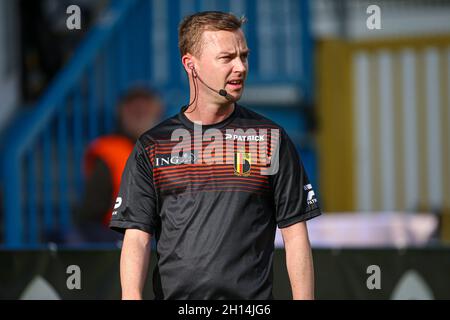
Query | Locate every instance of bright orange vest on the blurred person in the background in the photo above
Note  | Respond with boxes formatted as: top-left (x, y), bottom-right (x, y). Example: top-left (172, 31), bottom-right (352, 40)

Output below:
top-left (84, 135), bottom-right (134, 225)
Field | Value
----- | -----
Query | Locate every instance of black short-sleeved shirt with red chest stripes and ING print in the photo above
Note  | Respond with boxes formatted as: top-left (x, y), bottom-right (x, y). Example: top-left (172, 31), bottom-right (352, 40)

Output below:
top-left (110, 104), bottom-right (320, 299)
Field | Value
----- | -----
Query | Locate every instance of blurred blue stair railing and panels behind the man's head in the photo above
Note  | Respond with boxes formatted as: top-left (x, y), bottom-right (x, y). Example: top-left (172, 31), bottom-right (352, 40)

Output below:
top-left (1, 0), bottom-right (312, 248)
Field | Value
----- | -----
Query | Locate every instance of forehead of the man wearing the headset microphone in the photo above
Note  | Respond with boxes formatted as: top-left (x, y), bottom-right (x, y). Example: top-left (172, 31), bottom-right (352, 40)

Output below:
top-left (202, 29), bottom-right (248, 52)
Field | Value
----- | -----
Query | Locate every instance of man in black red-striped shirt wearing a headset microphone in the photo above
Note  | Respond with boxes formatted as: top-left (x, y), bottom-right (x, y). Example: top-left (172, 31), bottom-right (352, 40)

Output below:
top-left (110, 12), bottom-right (320, 299)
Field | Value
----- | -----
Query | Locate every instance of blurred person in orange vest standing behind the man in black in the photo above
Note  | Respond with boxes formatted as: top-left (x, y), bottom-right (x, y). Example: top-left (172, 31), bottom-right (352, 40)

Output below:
top-left (76, 88), bottom-right (163, 242)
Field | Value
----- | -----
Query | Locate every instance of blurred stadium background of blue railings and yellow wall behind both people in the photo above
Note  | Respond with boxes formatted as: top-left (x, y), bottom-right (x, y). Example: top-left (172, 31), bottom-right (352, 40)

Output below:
top-left (0, 0), bottom-right (450, 299)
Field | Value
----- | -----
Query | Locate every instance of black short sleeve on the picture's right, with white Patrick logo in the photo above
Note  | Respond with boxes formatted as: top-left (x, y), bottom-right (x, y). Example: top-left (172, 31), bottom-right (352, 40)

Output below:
top-left (272, 130), bottom-right (321, 228)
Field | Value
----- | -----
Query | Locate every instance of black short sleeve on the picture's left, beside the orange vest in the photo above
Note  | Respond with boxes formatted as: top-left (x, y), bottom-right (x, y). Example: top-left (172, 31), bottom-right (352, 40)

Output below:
top-left (109, 140), bottom-right (158, 234)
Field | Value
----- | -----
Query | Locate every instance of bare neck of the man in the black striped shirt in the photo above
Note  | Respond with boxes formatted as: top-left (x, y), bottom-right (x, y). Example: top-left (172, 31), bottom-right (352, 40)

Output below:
top-left (184, 101), bottom-right (235, 125)
